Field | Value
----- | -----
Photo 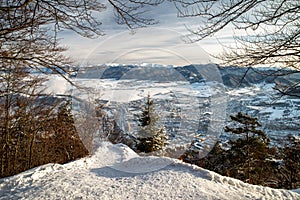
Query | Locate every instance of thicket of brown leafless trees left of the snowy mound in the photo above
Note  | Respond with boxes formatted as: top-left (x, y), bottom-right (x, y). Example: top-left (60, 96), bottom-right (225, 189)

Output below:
top-left (0, 65), bottom-right (89, 177)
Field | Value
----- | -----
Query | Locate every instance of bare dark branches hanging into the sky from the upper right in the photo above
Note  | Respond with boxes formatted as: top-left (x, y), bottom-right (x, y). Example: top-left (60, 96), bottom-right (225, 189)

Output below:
top-left (173, 0), bottom-right (300, 96)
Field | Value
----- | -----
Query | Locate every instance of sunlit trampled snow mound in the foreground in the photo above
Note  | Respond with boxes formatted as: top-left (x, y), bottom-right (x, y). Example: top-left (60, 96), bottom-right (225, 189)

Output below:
top-left (0, 143), bottom-right (300, 200)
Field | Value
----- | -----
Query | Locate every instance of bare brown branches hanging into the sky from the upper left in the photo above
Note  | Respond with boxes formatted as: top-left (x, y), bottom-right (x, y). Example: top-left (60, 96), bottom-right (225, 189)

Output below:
top-left (0, 0), bottom-right (162, 79)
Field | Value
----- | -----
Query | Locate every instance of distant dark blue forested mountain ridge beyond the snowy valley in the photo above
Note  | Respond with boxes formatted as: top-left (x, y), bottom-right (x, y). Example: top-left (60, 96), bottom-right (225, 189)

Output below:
top-left (77, 64), bottom-right (300, 87)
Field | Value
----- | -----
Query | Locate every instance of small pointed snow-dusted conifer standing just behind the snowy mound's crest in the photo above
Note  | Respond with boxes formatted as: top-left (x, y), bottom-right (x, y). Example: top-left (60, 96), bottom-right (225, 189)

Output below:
top-left (137, 94), bottom-right (167, 153)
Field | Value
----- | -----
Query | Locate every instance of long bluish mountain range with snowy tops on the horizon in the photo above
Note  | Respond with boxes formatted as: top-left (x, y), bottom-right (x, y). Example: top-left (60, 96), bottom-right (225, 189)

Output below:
top-left (78, 64), bottom-right (300, 88)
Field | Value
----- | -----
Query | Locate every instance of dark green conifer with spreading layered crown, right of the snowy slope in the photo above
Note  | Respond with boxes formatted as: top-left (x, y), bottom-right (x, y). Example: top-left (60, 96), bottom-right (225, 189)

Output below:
top-left (225, 112), bottom-right (270, 184)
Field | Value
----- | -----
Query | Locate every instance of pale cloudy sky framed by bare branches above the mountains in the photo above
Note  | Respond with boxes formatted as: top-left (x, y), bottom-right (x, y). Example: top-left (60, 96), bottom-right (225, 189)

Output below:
top-left (60, 2), bottom-right (239, 65)
